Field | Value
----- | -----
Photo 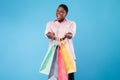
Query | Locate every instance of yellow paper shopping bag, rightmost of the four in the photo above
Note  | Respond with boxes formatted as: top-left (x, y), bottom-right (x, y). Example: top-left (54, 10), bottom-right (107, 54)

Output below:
top-left (60, 42), bottom-right (76, 74)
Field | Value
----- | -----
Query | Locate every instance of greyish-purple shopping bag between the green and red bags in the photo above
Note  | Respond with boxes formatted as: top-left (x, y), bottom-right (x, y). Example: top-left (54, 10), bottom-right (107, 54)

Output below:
top-left (48, 46), bottom-right (58, 80)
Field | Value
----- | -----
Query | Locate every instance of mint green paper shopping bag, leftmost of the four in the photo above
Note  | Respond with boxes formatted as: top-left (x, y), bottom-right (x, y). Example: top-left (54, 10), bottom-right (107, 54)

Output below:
top-left (40, 44), bottom-right (57, 75)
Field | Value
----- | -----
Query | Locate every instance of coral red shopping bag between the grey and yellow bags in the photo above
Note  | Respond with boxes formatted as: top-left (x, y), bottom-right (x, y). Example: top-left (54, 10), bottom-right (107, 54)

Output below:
top-left (58, 47), bottom-right (68, 80)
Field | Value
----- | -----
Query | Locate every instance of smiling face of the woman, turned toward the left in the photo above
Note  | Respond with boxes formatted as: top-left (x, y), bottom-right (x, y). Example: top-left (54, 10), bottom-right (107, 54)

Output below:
top-left (56, 7), bottom-right (67, 21)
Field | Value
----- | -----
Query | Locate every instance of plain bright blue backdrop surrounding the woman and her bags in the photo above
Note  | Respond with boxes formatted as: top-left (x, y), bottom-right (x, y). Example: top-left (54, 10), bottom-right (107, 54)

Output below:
top-left (0, 0), bottom-right (120, 80)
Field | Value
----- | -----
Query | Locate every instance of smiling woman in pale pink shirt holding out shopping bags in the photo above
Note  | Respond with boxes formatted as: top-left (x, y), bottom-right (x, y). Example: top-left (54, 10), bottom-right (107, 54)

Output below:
top-left (45, 4), bottom-right (76, 80)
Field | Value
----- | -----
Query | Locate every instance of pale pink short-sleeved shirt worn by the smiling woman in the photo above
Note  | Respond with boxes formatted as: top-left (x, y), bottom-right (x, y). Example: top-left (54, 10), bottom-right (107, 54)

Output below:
top-left (45, 19), bottom-right (76, 60)
